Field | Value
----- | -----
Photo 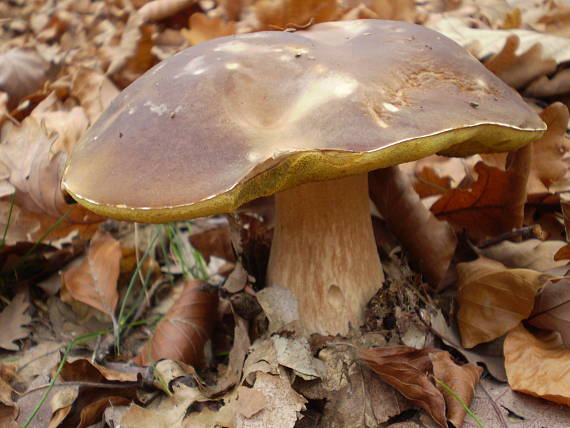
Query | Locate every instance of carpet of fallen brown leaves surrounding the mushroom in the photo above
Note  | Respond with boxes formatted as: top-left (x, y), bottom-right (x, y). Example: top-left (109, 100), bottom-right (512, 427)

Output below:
top-left (0, 0), bottom-right (570, 428)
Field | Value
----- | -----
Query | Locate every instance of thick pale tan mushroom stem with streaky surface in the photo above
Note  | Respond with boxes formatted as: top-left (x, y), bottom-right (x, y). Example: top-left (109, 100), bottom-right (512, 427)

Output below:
top-left (267, 174), bottom-right (384, 335)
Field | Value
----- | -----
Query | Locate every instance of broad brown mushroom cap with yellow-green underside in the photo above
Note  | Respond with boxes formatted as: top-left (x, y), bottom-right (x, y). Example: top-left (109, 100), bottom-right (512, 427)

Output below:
top-left (63, 20), bottom-right (545, 223)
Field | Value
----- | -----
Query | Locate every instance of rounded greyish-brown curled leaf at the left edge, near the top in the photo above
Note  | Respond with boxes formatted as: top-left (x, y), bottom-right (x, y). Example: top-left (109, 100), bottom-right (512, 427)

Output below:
top-left (0, 48), bottom-right (48, 109)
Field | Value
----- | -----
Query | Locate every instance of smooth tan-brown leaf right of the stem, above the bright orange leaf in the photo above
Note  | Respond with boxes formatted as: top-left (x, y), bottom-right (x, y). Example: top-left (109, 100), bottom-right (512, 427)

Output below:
top-left (457, 258), bottom-right (547, 348)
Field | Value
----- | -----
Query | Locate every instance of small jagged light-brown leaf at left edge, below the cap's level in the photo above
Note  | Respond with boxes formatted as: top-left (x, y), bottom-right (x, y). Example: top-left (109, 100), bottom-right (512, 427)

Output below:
top-left (0, 288), bottom-right (32, 351)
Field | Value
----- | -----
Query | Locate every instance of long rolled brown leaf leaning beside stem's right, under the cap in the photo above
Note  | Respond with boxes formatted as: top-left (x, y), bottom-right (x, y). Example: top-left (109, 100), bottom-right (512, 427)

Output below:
top-left (369, 167), bottom-right (457, 287)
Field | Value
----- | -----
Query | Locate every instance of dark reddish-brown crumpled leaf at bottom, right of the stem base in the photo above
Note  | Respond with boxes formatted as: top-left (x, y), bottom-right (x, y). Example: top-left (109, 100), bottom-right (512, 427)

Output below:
top-left (358, 346), bottom-right (447, 427)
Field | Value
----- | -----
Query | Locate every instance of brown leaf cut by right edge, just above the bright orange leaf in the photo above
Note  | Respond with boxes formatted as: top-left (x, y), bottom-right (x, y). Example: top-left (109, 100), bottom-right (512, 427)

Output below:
top-left (528, 278), bottom-right (570, 348)
